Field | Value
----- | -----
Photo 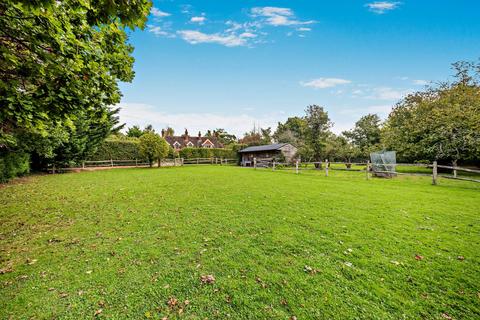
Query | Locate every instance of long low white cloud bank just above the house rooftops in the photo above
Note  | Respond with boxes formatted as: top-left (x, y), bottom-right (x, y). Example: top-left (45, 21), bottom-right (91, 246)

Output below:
top-left (117, 103), bottom-right (286, 136)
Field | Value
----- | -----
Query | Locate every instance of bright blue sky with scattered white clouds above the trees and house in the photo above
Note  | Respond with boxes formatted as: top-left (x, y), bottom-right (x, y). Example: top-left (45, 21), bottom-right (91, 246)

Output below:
top-left (120, 0), bottom-right (480, 135)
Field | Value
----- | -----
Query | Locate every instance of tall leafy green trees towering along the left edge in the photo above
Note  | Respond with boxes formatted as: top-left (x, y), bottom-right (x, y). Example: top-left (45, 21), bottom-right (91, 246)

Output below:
top-left (0, 0), bottom-right (151, 180)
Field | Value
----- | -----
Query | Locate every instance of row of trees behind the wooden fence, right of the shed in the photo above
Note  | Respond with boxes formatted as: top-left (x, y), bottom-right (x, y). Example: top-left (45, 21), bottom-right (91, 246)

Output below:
top-left (248, 62), bottom-right (480, 164)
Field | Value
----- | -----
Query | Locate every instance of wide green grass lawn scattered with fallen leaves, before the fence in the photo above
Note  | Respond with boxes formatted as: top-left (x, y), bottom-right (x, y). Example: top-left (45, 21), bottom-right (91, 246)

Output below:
top-left (0, 166), bottom-right (480, 319)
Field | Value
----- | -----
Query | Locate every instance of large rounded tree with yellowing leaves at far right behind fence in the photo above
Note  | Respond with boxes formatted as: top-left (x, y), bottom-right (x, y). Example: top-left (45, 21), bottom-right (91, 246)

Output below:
top-left (383, 62), bottom-right (480, 164)
